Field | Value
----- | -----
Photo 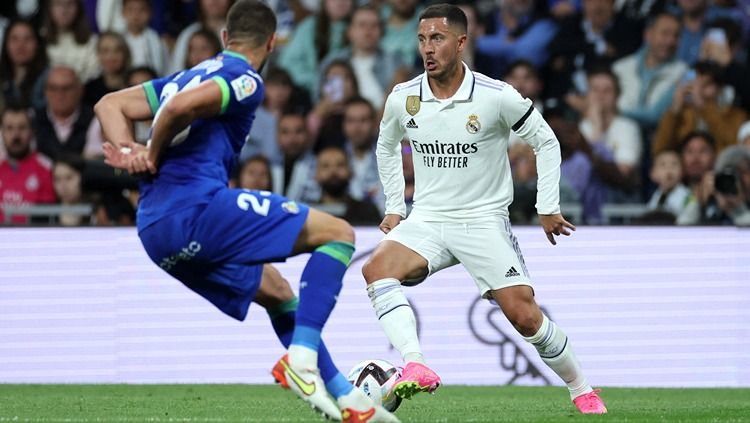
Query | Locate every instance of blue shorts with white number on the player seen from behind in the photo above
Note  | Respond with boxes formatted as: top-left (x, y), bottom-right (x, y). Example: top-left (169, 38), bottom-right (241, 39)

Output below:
top-left (139, 188), bottom-right (309, 320)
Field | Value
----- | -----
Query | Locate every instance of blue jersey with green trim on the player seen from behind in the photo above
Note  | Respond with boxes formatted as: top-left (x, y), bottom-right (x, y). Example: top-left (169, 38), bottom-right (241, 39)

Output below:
top-left (137, 50), bottom-right (264, 230)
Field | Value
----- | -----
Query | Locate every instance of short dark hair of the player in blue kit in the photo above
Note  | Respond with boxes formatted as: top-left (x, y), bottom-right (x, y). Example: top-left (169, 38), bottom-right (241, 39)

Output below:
top-left (227, 0), bottom-right (276, 47)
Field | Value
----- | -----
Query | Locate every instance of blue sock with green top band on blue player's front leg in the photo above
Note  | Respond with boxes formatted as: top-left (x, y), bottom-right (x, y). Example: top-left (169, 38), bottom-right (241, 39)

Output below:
top-left (292, 242), bottom-right (354, 351)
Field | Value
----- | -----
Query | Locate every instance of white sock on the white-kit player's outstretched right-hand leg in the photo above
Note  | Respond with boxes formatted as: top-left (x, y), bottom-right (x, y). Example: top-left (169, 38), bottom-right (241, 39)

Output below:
top-left (523, 315), bottom-right (592, 399)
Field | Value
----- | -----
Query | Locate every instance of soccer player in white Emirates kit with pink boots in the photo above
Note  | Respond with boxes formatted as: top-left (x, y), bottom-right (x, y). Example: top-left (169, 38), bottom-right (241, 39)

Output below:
top-left (362, 4), bottom-right (607, 414)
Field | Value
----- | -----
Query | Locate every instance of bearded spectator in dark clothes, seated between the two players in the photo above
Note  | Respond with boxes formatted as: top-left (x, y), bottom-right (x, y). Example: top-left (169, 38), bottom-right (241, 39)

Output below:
top-left (315, 147), bottom-right (382, 225)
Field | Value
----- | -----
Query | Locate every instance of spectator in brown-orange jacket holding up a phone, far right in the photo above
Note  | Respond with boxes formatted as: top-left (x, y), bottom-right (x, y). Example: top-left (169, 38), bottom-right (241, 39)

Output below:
top-left (652, 62), bottom-right (747, 154)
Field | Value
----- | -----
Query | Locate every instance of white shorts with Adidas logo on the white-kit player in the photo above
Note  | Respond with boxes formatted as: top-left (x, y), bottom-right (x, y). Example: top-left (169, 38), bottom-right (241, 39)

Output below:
top-left (383, 216), bottom-right (531, 298)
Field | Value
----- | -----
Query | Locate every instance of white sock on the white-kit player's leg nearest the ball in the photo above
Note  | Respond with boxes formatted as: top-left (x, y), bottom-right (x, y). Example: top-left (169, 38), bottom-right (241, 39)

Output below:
top-left (367, 278), bottom-right (424, 364)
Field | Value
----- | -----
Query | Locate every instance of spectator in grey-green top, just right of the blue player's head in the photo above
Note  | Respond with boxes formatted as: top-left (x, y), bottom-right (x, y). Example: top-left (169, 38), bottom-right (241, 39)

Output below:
top-left (278, 0), bottom-right (356, 93)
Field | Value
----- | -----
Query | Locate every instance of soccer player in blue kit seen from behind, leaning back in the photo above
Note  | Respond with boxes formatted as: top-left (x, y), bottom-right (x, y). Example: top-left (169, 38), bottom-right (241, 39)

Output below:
top-left (95, 0), bottom-right (398, 422)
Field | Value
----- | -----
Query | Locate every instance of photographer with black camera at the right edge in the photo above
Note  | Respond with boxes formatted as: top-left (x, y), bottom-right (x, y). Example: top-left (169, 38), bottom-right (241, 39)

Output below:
top-left (677, 145), bottom-right (750, 226)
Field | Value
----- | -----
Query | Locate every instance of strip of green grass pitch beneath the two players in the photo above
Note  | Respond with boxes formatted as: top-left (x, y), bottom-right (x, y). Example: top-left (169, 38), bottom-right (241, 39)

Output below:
top-left (0, 384), bottom-right (750, 422)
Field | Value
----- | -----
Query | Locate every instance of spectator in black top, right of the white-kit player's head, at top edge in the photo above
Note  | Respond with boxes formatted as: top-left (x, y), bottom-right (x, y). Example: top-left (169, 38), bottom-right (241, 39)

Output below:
top-left (546, 0), bottom-right (641, 98)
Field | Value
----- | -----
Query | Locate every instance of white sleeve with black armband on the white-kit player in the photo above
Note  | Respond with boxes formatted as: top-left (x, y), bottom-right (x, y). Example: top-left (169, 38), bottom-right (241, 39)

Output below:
top-left (500, 86), bottom-right (562, 215)
